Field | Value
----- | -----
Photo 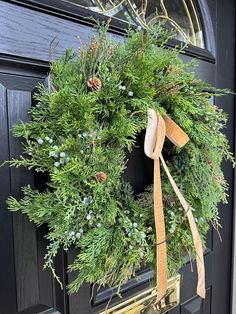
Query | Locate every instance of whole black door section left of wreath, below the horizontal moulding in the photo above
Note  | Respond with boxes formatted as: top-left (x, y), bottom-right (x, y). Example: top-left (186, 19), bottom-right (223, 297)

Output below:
top-left (0, 73), bottom-right (56, 314)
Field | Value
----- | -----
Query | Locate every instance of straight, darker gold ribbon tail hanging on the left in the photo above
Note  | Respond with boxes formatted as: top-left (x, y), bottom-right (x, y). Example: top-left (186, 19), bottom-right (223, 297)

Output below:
top-left (154, 158), bottom-right (167, 302)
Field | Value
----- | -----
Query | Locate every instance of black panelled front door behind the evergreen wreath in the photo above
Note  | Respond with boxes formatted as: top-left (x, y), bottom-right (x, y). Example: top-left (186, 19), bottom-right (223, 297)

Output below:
top-left (0, 0), bottom-right (235, 314)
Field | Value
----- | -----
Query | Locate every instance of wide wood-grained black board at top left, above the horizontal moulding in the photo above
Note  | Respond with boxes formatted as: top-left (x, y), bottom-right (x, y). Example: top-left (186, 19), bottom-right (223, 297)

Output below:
top-left (0, 1), bottom-right (103, 61)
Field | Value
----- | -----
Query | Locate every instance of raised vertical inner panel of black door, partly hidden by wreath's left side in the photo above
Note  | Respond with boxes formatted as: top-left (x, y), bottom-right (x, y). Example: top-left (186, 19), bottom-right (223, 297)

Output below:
top-left (7, 90), bottom-right (39, 311)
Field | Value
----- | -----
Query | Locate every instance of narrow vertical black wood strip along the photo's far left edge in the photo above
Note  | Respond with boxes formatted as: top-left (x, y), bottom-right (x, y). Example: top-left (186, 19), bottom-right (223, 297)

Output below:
top-left (0, 83), bottom-right (16, 313)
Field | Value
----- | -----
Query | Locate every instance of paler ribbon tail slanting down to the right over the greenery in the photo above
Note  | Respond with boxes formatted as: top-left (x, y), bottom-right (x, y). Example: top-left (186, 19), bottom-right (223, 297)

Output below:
top-left (160, 155), bottom-right (206, 299)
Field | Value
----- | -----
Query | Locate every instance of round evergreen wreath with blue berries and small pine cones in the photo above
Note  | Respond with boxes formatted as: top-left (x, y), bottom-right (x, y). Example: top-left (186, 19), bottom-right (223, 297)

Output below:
top-left (8, 25), bottom-right (234, 293)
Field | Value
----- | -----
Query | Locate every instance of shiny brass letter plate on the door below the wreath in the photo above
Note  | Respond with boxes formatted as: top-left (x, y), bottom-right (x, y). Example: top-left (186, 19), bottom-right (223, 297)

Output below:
top-left (100, 275), bottom-right (180, 314)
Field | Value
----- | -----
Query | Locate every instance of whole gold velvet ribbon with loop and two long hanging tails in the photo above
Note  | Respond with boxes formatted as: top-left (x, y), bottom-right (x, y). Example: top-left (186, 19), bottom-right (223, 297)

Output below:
top-left (144, 109), bottom-right (206, 301)
